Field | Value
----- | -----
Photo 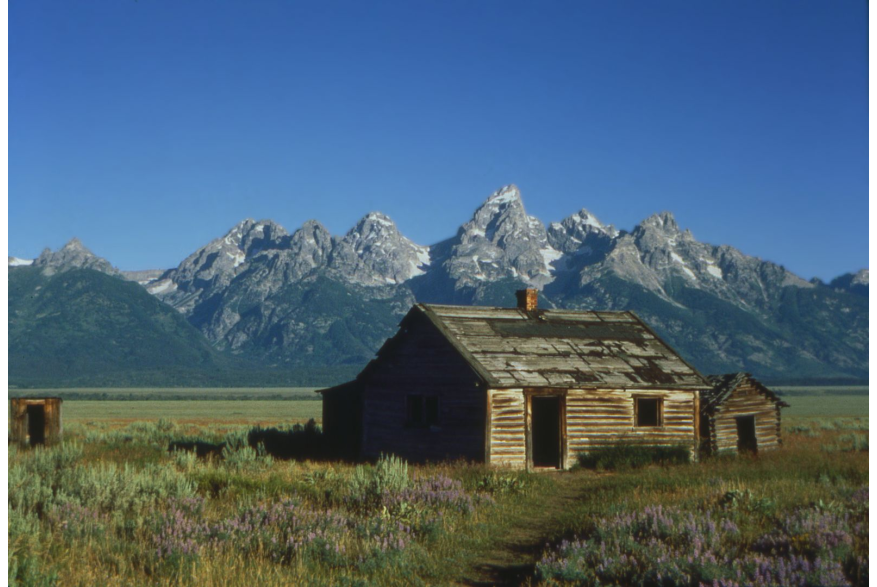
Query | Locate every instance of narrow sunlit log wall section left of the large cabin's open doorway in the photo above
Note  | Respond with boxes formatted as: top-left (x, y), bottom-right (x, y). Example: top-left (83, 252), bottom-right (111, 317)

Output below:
top-left (488, 389), bottom-right (527, 469)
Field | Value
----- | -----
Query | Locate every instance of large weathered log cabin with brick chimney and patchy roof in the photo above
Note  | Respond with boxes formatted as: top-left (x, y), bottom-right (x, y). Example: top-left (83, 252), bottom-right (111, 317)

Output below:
top-left (321, 290), bottom-right (710, 469)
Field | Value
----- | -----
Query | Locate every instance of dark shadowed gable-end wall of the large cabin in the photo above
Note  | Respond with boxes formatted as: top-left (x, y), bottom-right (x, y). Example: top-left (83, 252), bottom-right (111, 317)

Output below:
top-left (362, 318), bottom-right (487, 462)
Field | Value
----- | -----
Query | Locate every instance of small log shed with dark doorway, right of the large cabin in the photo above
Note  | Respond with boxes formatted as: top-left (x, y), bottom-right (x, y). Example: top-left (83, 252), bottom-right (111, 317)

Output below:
top-left (700, 373), bottom-right (789, 455)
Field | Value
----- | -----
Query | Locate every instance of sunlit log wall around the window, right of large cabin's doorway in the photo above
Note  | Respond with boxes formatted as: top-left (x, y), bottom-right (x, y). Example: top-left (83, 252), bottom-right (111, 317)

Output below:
top-left (566, 390), bottom-right (696, 464)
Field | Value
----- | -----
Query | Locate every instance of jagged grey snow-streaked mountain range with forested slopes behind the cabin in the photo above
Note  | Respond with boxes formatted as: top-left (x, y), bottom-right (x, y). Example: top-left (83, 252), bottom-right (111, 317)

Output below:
top-left (10, 186), bottom-right (869, 378)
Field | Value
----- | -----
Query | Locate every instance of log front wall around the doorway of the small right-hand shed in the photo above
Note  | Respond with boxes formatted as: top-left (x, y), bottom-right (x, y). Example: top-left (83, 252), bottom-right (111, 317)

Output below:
top-left (710, 385), bottom-right (782, 454)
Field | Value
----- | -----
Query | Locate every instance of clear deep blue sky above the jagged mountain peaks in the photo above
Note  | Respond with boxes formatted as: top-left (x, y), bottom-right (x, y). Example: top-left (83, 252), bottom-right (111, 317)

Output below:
top-left (8, 0), bottom-right (870, 278)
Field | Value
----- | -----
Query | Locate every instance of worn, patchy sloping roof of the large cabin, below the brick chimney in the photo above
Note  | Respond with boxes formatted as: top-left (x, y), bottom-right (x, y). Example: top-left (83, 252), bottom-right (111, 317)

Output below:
top-left (418, 305), bottom-right (710, 389)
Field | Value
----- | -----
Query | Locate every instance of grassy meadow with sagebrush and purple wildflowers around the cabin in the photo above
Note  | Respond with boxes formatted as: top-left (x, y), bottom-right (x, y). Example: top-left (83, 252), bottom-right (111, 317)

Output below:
top-left (7, 392), bottom-right (870, 587)
